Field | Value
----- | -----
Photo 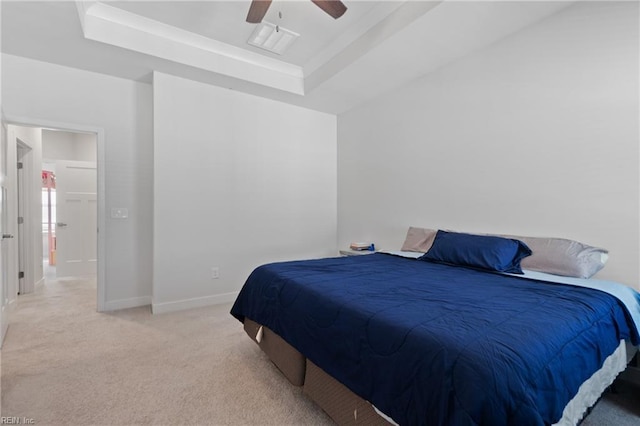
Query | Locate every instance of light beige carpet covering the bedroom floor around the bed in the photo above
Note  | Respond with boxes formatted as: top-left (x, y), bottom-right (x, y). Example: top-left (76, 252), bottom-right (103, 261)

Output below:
top-left (1, 279), bottom-right (640, 426)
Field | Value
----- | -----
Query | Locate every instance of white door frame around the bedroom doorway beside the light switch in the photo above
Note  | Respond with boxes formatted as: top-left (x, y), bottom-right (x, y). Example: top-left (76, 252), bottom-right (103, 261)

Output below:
top-left (5, 114), bottom-right (107, 312)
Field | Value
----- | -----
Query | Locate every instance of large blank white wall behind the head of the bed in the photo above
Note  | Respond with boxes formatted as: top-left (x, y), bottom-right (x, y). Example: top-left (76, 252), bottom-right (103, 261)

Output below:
top-left (338, 2), bottom-right (640, 288)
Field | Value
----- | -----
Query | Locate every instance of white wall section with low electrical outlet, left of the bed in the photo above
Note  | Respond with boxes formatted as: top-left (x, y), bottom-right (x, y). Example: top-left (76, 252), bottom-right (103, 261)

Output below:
top-left (153, 73), bottom-right (337, 312)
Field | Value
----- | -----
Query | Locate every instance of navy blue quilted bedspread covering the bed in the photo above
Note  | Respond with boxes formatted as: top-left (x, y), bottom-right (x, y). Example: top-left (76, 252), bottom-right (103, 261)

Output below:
top-left (231, 254), bottom-right (640, 425)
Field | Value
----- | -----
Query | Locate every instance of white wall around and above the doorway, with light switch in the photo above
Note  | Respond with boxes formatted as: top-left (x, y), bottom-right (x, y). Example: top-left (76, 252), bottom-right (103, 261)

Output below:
top-left (2, 55), bottom-right (153, 309)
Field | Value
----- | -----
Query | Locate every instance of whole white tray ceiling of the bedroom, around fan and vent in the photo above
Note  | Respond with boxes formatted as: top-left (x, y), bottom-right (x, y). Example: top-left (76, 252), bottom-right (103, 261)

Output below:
top-left (2, 0), bottom-right (572, 113)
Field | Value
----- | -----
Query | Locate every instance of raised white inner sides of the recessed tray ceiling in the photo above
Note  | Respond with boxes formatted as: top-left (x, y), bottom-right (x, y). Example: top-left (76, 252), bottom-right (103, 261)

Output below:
top-left (76, 0), bottom-right (440, 95)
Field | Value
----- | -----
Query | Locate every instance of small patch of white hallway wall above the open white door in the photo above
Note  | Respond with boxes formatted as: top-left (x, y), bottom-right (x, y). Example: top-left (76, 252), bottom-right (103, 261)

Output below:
top-left (42, 129), bottom-right (97, 163)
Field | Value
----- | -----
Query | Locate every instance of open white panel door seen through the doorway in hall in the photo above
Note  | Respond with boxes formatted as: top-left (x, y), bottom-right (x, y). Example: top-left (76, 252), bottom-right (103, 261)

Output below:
top-left (55, 161), bottom-right (98, 277)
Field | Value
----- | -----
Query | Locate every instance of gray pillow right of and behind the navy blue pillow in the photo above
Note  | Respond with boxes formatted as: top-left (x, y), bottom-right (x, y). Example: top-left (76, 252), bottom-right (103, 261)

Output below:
top-left (508, 235), bottom-right (609, 278)
